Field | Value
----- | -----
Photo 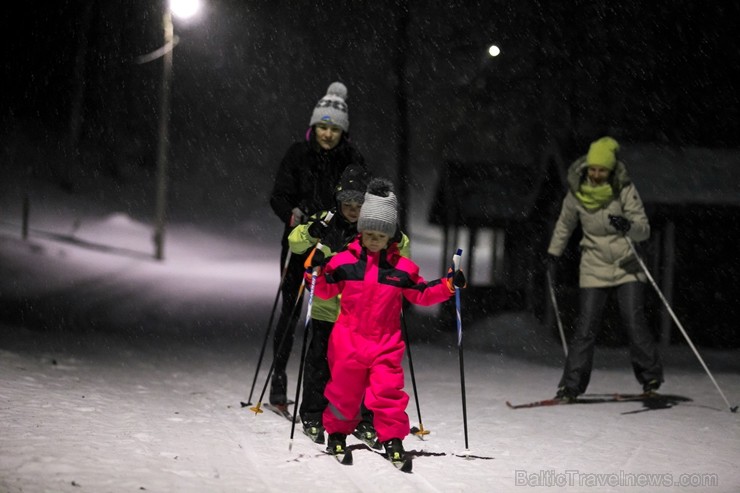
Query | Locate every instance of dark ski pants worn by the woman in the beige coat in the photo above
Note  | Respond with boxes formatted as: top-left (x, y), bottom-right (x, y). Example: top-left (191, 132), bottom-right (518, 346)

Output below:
top-left (559, 282), bottom-right (663, 394)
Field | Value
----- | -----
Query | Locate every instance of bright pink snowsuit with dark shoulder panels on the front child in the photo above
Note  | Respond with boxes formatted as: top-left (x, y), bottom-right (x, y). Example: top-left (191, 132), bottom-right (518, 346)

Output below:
top-left (314, 237), bottom-right (453, 442)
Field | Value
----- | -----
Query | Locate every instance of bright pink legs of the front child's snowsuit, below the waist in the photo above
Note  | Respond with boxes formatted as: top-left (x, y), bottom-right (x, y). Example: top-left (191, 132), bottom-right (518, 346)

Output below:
top-left (323, 323), bottom-right (409, 442)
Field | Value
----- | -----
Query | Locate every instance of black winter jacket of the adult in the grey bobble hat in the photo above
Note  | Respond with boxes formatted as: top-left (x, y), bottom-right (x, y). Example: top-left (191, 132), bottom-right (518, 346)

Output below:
top-left (270, 133), bottom-right (367, 236)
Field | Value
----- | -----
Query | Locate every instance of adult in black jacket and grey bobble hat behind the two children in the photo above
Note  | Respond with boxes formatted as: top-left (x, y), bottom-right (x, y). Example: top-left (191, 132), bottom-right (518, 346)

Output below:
top-left (270, 82), bottom-right (367, 405)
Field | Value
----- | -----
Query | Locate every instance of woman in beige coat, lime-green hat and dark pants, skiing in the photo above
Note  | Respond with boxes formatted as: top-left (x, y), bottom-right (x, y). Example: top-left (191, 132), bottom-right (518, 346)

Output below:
top-left (547, 137), bottom-right (663, 401)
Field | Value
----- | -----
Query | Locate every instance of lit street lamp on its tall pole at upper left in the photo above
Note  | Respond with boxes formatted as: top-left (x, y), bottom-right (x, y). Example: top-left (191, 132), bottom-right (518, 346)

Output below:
top-left (153, 0), bottom-right (200, 260)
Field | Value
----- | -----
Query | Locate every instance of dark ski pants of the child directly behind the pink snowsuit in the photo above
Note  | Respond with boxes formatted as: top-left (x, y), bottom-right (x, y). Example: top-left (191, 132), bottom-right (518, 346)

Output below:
top-left (300, 319), bottom-right (373, 424)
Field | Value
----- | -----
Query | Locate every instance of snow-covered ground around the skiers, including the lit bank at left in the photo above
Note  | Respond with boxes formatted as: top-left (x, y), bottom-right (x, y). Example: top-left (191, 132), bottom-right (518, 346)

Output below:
top-left (0, 174), bottom-right (740, 493)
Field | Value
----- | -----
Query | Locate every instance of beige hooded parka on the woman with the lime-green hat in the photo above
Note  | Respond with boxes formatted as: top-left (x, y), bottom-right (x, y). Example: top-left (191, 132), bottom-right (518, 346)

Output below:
top-left (547, 156), bottom-right (650, 288)
